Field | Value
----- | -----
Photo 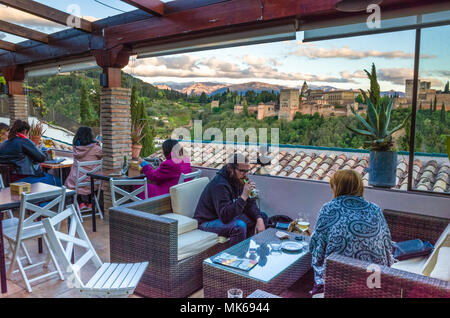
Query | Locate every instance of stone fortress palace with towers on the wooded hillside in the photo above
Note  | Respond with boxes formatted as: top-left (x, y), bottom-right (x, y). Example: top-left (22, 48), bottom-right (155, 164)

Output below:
top-left (229, 79), bottom-right (450, 121)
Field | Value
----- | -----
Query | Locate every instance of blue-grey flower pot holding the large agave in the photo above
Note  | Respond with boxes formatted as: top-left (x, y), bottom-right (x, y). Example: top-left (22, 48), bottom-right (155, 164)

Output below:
top-left (366, 151), bottom-right (397, 188)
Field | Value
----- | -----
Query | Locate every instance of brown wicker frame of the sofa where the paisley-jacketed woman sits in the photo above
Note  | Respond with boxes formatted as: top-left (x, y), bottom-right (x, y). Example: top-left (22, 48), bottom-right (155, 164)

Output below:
top-left (324, 210), bottom-right (450, 298)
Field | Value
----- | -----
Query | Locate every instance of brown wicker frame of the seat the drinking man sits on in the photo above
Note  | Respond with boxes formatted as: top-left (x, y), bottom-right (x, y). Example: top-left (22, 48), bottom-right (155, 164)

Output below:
top-left (109, 194), bottom-right (228, 298)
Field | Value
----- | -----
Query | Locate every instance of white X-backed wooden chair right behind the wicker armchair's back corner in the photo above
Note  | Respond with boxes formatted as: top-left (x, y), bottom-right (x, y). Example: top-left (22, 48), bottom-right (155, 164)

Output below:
top-left (110, 178), bottom-right (148, 206)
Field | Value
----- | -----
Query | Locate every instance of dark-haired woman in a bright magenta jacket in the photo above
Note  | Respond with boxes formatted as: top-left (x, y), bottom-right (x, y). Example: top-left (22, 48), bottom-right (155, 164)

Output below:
top-left (139, 139), bottom-right (191, 198)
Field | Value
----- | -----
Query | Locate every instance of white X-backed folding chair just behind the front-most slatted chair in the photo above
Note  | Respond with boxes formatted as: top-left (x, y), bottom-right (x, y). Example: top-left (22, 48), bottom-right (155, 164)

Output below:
top-left (3, 187), bottom-right (66, 293)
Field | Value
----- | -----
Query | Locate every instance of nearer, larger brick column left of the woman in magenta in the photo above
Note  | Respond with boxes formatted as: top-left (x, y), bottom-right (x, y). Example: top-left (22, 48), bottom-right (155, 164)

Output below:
top-left (100, 87), bottom-right (131, 215)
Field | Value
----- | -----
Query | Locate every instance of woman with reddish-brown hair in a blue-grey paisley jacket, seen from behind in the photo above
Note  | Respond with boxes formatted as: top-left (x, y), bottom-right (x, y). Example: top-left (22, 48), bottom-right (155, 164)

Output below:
top-left (310, 170), bottom-right (394, 294)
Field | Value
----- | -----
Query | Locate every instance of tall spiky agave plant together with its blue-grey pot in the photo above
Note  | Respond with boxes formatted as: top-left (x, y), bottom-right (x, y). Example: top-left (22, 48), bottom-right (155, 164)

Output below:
top-left (346, 64), bottom-right (411, 188)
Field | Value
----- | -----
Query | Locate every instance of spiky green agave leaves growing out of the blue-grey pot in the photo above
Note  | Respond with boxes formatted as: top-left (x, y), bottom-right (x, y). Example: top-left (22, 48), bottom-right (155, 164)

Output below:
top-left (346, 98), bottom-right (411, 151)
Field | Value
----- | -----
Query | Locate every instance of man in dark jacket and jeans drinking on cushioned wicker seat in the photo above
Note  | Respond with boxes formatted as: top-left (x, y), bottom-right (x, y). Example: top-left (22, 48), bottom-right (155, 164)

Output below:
top-left (194, 154), bottom-right (267, 245)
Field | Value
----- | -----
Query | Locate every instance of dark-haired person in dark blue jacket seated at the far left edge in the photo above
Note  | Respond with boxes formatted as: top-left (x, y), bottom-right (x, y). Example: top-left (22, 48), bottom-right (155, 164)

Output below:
top-left (0, 120), bottom-right (61, 186)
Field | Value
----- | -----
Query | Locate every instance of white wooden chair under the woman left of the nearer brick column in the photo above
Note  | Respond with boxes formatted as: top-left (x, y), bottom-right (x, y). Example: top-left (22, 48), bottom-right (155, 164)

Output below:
top-left (74, 160), bottom-right (103, 222)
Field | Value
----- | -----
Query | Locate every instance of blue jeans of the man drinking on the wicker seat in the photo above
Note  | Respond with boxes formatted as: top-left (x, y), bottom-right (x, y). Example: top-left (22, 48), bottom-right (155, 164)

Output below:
top-left (199, 213), bottom-right (267, 246)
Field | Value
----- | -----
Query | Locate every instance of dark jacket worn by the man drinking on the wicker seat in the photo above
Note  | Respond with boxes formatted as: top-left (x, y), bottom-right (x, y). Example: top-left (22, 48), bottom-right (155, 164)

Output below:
top-left (194, 167), bottom-right (261, 224)
